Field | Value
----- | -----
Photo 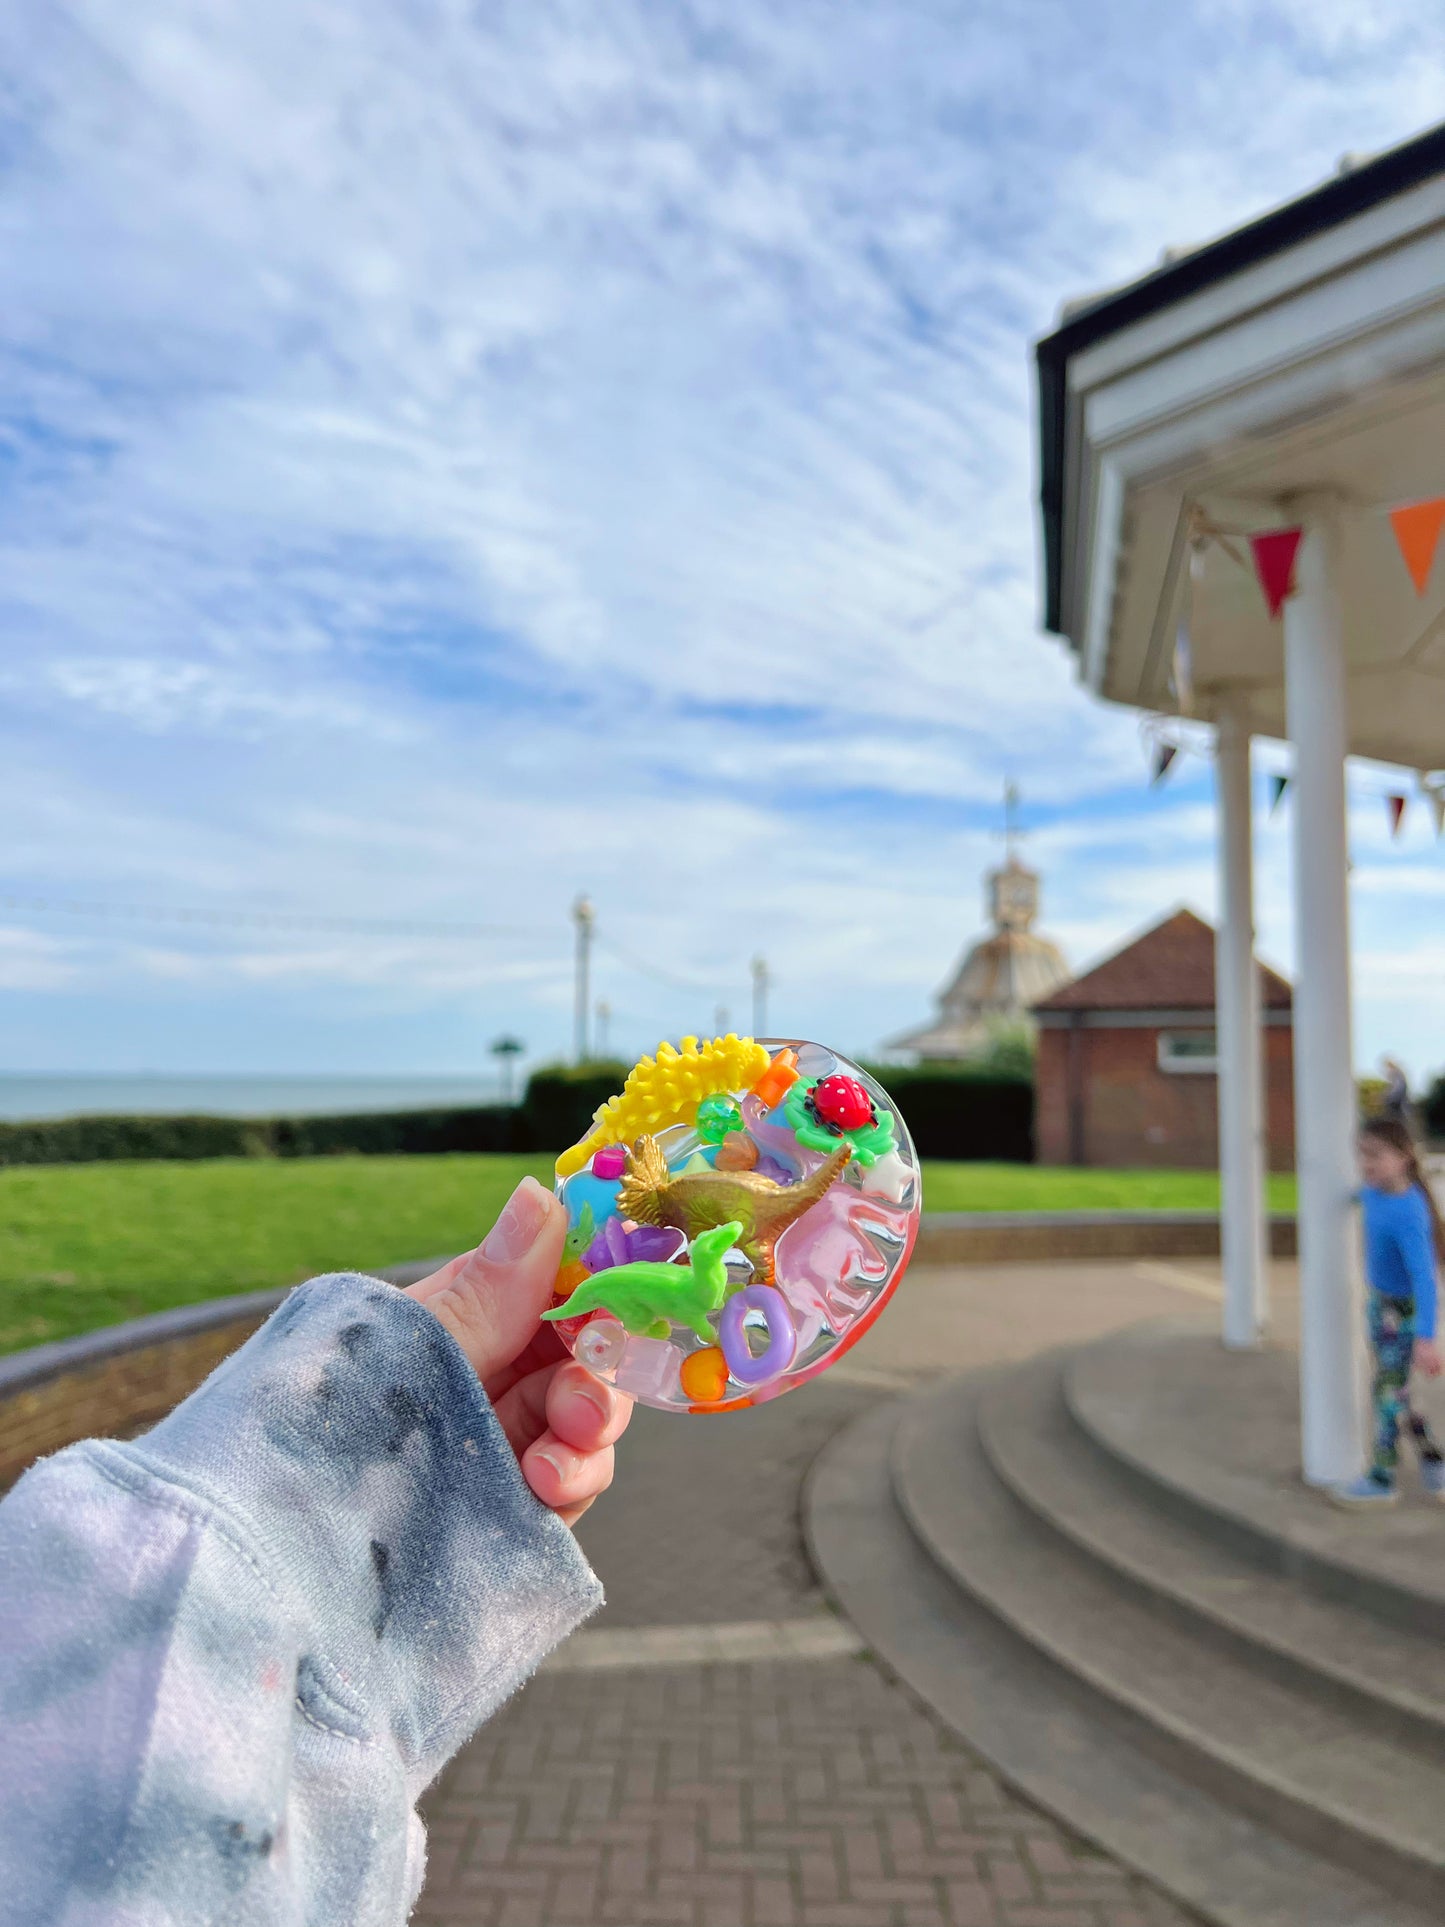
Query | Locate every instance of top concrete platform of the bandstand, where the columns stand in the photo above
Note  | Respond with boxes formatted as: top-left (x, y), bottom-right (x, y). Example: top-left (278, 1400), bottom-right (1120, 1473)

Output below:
top-left (1064, 1322), bottom-right (1445, 1640)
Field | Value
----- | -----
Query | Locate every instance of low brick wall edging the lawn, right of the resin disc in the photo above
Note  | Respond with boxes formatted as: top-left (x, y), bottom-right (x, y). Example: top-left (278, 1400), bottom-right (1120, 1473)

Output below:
top-left (913, 1210), bottom-right (1295, 1264)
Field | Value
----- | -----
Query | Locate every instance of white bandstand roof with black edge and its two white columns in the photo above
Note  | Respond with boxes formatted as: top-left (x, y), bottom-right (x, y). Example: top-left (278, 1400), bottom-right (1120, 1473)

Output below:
top-left (1037, 127), bottom-right (1445, 1484)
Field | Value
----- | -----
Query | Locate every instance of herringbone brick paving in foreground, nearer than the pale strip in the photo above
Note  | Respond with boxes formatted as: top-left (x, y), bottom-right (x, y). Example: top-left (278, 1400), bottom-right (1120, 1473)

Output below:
top-left (418, 1659), bottom-right (1185, 1927)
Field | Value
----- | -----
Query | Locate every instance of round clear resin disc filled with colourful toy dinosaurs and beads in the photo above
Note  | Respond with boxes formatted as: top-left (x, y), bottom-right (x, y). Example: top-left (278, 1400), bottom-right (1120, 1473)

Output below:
top-left (543, 1037), bottom-right (921, 1412)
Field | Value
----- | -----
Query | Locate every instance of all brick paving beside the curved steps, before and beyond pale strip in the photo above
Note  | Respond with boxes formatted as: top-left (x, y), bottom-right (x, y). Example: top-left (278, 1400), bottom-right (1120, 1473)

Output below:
top-left (416, 1266), bottom-right (1271, 1927)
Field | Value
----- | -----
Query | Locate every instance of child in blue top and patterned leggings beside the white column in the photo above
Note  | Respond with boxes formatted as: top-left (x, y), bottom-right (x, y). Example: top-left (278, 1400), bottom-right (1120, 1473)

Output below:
top-left (1329, 1118), bottom-right (1445, 1507)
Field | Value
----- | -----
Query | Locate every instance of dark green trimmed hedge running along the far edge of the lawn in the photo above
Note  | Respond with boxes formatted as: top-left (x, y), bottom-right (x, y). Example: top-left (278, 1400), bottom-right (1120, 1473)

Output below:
top-left (0, 1064), bottom-right (1033, 1164)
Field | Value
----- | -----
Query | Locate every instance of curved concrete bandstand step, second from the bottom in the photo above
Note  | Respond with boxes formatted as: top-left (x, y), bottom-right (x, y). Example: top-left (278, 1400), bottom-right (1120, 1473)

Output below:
top-left (892, 1382), bottom-right (1445, 1915)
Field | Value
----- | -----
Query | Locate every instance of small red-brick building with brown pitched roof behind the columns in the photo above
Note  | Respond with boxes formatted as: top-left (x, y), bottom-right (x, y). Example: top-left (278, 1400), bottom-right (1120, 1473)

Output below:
top-left (1035, 910), bottom-right (1295, 1172)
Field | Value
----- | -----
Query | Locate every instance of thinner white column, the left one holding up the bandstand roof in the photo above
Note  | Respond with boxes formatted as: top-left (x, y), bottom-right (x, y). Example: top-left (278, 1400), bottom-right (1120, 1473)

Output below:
top-left (1214, 692), bottom-right (1270, 1351)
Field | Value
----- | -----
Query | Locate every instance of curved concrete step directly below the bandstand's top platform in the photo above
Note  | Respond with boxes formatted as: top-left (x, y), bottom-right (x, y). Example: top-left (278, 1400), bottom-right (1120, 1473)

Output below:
top-left (979, 1357), bottom-right (1445, 1759)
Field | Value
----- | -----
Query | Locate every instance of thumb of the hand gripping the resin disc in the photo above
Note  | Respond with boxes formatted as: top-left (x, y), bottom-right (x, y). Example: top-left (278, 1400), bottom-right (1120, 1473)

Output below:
top-left (408, 1177), bottom-right (566, 1378)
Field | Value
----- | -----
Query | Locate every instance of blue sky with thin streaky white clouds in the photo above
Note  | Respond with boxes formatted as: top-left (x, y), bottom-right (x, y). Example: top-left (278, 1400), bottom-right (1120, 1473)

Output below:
top-left (0, 0), bottom-right (1445, 1075)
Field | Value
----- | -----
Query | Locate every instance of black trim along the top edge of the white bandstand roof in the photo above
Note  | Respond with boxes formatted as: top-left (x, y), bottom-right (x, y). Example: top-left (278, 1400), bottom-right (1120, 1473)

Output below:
top-left (1035, 121), bottom-right (1445, 634)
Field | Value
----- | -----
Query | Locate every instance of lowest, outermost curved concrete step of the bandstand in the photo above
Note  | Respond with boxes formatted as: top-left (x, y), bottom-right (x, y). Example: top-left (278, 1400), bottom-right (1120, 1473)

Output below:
top-left (803, 1401), bottom-right (1437, 1927)
